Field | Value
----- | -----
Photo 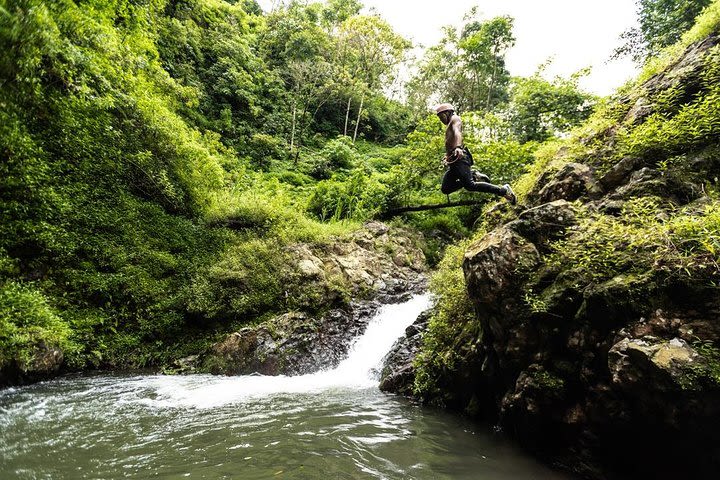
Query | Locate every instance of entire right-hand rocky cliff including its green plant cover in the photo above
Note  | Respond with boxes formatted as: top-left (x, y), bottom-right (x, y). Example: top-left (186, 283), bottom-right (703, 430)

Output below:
top-left (387, 29), bottom-right (720, 478)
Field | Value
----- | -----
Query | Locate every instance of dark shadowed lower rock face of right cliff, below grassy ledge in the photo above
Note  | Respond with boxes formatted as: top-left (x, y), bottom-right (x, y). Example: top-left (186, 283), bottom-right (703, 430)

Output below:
top-left (456, 204), bottom-right (720, 478)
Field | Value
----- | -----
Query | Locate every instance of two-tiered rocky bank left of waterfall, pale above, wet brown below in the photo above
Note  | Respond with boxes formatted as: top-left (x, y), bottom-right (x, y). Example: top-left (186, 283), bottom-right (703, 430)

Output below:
top-left (198, 222), bottom-right (425, 375)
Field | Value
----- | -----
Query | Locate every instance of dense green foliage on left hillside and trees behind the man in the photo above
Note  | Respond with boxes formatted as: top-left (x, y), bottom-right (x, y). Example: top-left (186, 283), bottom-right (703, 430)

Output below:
top-left (0, 0), bottom-right (592, 382)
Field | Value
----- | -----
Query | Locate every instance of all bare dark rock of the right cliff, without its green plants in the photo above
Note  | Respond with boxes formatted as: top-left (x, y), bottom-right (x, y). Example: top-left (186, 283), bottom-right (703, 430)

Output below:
top-left (387, 36), bottom-right (720, 478)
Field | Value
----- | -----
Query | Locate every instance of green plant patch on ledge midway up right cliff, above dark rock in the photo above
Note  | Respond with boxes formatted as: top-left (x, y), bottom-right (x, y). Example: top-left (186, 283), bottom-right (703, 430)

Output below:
top-left (547, 197), bottom-right (720, 283)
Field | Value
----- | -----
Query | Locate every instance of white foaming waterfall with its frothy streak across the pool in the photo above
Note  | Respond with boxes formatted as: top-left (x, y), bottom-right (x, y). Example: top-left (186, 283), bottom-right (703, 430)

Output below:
top-left (138, 294), bottom-right (430, 408)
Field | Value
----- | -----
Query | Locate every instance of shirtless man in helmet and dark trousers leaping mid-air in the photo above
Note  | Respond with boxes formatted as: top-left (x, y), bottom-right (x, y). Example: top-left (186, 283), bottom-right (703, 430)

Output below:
top-left (435, 103), bottom-right (517, 205)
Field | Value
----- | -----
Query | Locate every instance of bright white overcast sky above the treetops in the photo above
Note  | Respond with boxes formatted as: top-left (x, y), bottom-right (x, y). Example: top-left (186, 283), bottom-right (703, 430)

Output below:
top-left (258, 0), bottom-right (637, 96)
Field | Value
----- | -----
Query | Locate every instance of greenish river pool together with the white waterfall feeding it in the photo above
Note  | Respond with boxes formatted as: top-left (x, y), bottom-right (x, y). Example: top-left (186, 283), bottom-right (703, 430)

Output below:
top-left (0, 295), bottom-right (569, 480)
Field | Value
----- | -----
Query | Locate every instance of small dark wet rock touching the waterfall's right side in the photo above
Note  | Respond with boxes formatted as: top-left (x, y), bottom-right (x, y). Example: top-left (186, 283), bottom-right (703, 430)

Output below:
top-left (380, 310), bottom-right (431, 396)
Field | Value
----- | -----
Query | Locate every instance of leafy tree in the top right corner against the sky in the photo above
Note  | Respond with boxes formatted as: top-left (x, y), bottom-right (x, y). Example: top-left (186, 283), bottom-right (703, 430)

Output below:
top-left (613, 0), bottom-right (712, 62)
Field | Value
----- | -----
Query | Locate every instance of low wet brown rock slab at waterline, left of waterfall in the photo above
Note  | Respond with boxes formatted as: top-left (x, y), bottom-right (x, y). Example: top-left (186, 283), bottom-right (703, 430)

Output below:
top-left (202, 277), bottom-right (425, 375)
